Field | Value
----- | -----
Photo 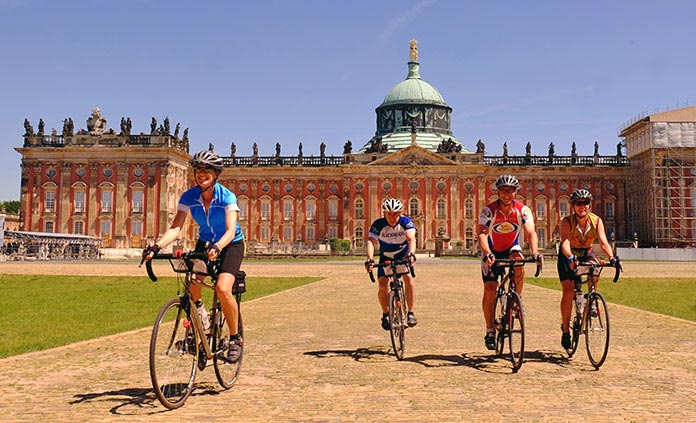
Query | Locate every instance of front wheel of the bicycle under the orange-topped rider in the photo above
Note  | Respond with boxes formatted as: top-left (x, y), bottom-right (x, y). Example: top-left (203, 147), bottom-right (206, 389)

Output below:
top-left (585, 292), bottom-right (609, 369)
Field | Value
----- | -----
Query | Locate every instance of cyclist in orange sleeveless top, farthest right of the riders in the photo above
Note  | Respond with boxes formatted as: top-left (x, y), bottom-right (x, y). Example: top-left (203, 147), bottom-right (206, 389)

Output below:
top-left (558, 189), bottom-right (614, 349)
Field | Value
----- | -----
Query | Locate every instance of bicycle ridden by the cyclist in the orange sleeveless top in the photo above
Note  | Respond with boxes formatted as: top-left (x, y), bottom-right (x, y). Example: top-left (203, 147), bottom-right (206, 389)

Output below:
top-left (566, 257), bottom-right (623, 370)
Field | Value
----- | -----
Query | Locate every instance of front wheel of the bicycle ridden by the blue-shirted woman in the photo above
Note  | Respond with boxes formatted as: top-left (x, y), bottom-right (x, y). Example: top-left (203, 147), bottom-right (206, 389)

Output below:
top-left (150, 298), bottom-right (198, 409)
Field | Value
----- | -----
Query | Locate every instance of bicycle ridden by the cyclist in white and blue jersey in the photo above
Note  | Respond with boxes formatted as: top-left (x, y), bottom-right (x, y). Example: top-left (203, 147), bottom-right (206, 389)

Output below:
top-left (368, 260), bottom-right (416, 360)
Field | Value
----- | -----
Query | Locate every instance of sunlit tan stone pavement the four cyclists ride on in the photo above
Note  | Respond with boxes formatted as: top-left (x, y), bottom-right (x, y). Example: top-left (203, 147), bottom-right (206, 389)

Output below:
top-left (0, 258), bottom-right (696, 422)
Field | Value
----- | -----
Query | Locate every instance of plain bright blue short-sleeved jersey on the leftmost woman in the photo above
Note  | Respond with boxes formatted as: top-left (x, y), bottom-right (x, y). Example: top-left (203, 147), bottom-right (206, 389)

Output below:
top-left (177, 183), bottom-right (244, 242)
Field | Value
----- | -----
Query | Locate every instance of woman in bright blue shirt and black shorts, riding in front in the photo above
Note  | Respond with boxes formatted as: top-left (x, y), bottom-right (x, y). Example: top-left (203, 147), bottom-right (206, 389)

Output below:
top-left (143, 150), bottom-right (244, 362)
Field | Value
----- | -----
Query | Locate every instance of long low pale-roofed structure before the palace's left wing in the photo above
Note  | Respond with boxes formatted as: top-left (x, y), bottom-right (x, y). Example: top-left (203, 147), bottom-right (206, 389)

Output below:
top-left (3, 231), bottom-right (102, 260)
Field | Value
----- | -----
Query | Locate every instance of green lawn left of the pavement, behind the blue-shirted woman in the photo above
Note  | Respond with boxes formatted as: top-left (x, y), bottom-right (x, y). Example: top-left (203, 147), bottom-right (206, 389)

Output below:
top-left (0, 274), bottom-right (321, 358)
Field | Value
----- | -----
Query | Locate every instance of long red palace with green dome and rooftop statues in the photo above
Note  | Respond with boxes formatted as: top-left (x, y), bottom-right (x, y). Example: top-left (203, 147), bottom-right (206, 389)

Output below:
top-left (16, 40), bottom-right (696, 252)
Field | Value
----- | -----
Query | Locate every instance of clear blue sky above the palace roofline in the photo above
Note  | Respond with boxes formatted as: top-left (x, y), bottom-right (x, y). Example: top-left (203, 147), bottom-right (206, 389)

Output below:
top-left (0, 0), bottom-right (696, 201)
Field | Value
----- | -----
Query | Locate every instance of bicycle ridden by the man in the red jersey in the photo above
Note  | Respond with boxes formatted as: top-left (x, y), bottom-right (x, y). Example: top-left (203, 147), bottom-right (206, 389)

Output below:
top-left (492, 258), bottom-right (542, 373)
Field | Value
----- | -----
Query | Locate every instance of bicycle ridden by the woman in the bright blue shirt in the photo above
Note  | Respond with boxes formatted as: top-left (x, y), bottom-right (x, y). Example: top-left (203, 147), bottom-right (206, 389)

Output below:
top-left (140, 251), bottom-right (246, 410)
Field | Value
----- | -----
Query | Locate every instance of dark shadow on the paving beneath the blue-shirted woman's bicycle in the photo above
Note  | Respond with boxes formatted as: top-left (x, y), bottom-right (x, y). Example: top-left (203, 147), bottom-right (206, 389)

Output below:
top-left (69, 382), bottom-right (222, 416)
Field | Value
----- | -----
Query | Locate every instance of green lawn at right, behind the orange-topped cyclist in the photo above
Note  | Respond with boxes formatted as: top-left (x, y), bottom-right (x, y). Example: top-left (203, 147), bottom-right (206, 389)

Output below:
top-left (524, 277), bottom-right (696, 322)
